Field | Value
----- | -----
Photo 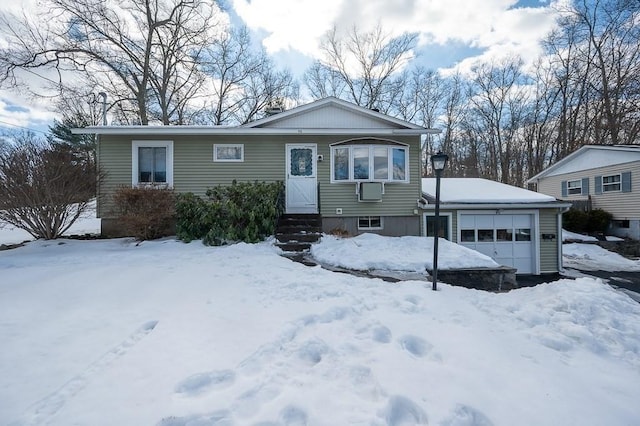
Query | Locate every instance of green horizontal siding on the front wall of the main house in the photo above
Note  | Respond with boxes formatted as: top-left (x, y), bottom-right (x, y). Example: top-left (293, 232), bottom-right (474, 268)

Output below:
top-left (99, 135), bottom-right (421, 223)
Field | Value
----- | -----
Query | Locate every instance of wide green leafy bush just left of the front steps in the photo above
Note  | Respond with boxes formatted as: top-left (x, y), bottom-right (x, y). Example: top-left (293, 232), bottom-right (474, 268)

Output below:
top-left (176, 181), bottom-right (284, 246)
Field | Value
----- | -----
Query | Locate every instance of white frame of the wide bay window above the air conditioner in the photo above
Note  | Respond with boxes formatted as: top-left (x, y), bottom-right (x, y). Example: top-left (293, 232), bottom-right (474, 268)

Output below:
top-left (330, 143), bottom-right (410, 183)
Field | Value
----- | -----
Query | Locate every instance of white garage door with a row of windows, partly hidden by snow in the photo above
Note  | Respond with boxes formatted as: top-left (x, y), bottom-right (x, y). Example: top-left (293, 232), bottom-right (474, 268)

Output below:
top-left (459, 214), bottom-right (535, 274)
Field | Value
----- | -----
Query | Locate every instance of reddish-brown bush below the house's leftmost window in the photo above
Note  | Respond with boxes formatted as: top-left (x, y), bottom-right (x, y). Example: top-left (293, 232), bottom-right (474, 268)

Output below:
top-left (113, 186), bottom-right (175, 241)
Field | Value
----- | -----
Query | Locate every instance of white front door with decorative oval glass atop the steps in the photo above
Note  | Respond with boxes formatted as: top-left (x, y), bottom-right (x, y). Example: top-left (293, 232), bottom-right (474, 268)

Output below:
top-left (285, 144), bottom-right (318, 213)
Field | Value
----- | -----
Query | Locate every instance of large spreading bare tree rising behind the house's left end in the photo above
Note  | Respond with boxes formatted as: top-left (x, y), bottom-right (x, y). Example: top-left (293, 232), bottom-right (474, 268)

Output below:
top-left (0, 0), bottom-right (217, 124)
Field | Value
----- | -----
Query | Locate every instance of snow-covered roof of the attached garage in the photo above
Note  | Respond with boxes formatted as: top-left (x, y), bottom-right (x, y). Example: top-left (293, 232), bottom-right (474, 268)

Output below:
top-left (422, 178), bottom-right (557, 204)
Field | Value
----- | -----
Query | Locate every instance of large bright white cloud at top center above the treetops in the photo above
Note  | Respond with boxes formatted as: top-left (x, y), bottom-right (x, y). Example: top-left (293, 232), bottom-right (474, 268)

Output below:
top-left (233, 0), bottom-right (553, 72)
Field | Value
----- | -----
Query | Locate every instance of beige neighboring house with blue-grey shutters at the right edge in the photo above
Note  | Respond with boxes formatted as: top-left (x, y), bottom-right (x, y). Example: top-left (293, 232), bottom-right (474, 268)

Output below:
top-left (528, 145), bottom-right (640, 240)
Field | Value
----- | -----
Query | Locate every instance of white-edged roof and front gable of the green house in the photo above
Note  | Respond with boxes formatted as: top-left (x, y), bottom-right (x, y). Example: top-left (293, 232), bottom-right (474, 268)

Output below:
top-left (73, 97), bottom-right (440, 136)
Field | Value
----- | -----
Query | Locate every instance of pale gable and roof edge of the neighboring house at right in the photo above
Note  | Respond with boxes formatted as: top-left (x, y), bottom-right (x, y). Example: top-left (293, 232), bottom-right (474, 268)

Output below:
top-left (527, 145), bottom-right (640, 183)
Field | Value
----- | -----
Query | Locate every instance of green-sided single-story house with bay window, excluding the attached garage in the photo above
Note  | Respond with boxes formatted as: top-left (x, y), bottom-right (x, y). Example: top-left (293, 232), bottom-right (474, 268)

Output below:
top-left (75, 97), bottom-right (438, 240)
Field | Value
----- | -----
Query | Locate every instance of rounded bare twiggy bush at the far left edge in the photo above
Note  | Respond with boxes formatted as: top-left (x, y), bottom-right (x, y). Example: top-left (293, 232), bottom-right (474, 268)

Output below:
top-left (0, 134), bottom-right (98, 240)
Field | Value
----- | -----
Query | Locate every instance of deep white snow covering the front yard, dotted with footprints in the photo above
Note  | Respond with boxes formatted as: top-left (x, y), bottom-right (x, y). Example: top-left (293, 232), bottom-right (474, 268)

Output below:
top-left (0, 216), bottom-right (640, 426)
